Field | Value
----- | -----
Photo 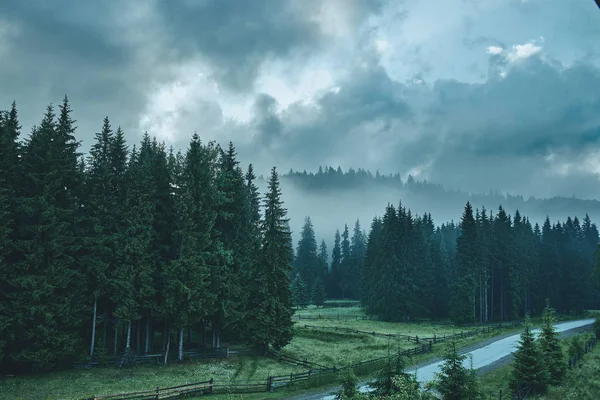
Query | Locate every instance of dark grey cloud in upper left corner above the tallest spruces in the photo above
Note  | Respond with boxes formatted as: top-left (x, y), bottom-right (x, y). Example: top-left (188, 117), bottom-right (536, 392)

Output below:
top-left (0, 0), bottom-right (148, 144)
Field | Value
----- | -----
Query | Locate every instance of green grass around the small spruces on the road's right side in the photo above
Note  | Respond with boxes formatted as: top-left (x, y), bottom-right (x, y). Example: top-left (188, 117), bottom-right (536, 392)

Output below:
top-left (480, 334), bottom-right (600, 400)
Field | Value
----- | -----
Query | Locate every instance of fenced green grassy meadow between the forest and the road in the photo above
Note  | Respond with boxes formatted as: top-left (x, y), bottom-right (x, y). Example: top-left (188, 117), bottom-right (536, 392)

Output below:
top-left (0, 307), bottom-right (584, 400)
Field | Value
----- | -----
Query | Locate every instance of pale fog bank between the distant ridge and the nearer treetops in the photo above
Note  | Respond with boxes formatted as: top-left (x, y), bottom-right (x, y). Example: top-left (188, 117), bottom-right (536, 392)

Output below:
top-left (258, 174), bottom-right (600, 255)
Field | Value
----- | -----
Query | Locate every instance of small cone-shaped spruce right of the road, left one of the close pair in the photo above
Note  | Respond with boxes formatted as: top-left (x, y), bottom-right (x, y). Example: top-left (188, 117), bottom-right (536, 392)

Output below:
top-left (509, 317), bottom-right (549, 398)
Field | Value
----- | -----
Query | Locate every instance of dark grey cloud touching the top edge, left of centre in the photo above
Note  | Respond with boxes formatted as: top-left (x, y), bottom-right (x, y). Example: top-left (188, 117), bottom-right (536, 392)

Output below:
top-left (158, 0), bottom-right (383, 90)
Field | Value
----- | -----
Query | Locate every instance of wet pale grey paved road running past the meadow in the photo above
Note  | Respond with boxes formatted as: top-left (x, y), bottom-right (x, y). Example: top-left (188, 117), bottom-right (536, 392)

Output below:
top-left (295, 319), bottom-right (595, 400)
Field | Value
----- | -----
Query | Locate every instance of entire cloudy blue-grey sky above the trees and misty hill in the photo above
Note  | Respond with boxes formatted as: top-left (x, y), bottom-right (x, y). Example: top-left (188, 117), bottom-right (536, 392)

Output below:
top-left (0, 0), bottom-right (600, 198)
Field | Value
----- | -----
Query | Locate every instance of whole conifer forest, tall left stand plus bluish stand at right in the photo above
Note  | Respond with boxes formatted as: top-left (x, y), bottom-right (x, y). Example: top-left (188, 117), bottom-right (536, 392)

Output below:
top-left (0, 97), bottom-right (600, 372)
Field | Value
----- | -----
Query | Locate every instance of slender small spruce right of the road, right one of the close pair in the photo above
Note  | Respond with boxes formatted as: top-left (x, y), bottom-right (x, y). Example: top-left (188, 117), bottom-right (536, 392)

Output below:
top-left (539, 301), bottom-right (567, 385)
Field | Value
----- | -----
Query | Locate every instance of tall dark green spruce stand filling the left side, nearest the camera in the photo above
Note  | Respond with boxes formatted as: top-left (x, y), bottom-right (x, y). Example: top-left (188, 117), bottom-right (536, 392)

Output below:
top-left (0, 97), bottom-right (293, 373)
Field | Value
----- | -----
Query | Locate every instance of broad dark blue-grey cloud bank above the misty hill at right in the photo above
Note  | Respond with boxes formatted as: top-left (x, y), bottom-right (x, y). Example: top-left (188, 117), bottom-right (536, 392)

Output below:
top-left (243, 50), bottom-right (600, 196)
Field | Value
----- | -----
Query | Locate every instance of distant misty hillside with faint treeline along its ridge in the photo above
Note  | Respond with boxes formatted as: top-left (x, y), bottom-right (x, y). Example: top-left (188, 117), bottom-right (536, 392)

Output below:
top-left (259, 167), bottom-right (600, 243)
